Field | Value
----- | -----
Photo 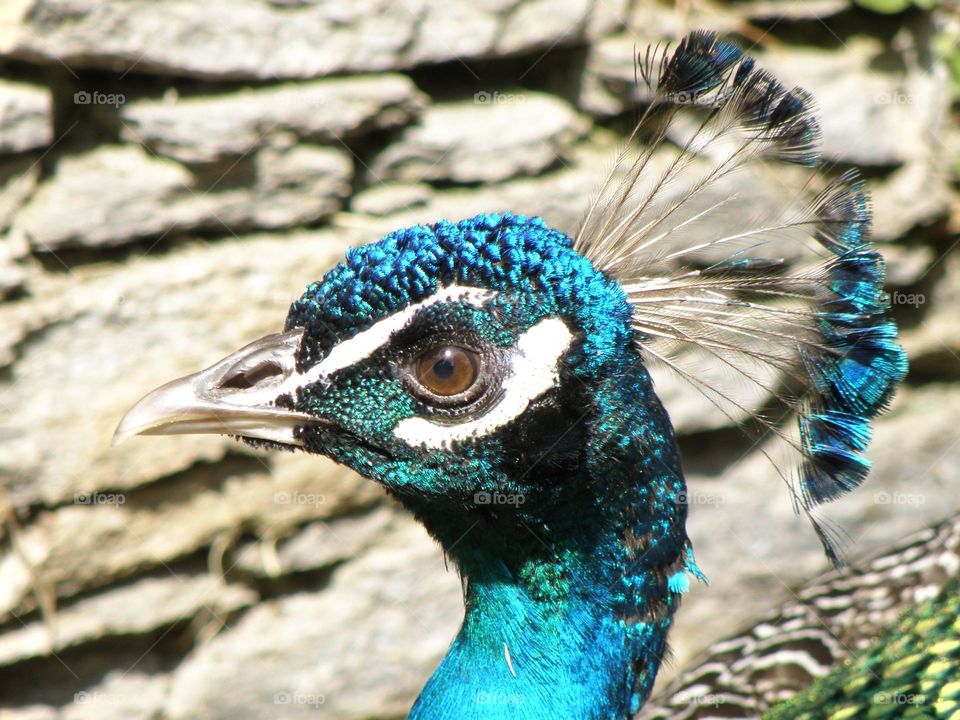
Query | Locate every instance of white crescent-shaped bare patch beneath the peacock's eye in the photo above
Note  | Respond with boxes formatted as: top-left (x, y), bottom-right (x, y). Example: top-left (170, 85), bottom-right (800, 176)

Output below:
top-left (393, 318), bottom-right (573, 449)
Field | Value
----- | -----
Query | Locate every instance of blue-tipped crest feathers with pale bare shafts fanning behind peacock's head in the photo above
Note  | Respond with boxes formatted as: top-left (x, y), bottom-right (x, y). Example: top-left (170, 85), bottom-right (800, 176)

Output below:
top-left (577, 33), bottom-right (907, 562)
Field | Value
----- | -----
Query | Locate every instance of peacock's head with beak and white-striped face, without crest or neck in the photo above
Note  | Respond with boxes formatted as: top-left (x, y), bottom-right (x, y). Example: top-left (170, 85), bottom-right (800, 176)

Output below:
top-left (118, 214), bottom-right (645, 520)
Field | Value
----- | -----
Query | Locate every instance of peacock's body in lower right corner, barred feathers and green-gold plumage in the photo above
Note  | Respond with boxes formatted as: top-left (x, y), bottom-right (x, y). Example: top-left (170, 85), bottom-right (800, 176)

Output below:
top-left (637, 515), bottom-right (960, 720)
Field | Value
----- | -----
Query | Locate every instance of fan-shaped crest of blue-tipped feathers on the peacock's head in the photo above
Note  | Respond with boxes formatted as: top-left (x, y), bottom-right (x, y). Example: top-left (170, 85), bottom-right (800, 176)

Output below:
top-left (574, 32), bottom-right (907, 564)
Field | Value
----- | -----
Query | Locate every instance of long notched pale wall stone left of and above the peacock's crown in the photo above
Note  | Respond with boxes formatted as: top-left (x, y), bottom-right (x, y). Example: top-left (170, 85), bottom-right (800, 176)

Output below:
top-left (13, 142), bottom-right (353, 252)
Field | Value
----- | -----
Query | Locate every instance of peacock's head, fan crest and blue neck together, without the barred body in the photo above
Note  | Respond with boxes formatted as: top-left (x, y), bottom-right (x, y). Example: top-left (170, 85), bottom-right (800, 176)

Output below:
top-left (116, 31), bottom-right (907, 720)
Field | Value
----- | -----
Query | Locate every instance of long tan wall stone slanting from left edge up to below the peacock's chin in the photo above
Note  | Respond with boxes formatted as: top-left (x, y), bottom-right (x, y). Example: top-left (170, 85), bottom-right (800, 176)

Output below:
top-left (0, 454), bottom-right (387, 614)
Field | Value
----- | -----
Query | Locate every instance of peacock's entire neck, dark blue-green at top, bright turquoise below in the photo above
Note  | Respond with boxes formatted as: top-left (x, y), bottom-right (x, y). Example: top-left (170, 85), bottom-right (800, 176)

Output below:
top-left (409, 368), bottom-right (698, 720)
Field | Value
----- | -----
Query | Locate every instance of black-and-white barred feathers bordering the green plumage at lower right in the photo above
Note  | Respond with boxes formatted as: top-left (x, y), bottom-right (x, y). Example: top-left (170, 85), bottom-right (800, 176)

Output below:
top-left (637, 515), bottom-right (960, 720)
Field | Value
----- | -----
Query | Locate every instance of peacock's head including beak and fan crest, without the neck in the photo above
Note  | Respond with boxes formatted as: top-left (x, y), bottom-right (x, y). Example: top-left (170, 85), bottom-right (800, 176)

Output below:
top-left (118, 32), bottom-right (907, 557)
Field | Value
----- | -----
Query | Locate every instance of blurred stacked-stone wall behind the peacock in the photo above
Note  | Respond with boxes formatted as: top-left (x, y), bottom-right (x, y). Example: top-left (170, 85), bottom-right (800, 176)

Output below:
top-left (0, 0), bottom-right (960, 720)
